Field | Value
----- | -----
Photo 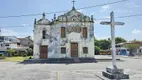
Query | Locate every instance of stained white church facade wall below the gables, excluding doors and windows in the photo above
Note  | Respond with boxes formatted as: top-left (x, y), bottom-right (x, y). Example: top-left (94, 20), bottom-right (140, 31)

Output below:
top-left (34, 22), bottom-right (94, 58)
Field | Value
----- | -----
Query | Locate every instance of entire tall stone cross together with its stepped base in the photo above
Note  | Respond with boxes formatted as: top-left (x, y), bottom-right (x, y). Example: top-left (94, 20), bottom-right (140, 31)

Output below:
top-left (100, 11), bottom-right (129, 79)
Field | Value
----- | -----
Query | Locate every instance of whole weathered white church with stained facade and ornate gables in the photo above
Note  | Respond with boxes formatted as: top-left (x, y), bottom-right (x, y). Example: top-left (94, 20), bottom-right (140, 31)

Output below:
top-left (33, 2), bottom-right (94, 59)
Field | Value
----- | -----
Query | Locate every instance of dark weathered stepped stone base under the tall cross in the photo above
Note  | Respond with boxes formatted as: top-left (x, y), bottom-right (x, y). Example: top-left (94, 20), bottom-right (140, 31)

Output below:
top-left (102, 68), bottom-right (129, 79)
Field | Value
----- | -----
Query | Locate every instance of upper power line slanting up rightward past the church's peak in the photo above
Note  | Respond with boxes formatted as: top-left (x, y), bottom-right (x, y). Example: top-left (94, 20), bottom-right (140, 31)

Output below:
top-left (0, 0), bottom-right (129, 18)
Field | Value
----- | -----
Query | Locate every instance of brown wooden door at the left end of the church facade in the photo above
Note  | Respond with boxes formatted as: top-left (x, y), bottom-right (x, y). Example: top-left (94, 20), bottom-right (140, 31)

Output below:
top-left (40, 46), bottom-right (48, 59)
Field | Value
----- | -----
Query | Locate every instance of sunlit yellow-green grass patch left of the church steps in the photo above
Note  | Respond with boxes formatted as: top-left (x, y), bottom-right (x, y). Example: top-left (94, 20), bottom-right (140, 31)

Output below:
top-left (3, 56), bottom-right (30, 62)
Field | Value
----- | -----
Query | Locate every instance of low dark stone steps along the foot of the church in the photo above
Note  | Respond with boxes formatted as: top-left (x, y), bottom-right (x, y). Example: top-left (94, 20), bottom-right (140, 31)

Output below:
top-left (20, 58), bottom-right (97, 64)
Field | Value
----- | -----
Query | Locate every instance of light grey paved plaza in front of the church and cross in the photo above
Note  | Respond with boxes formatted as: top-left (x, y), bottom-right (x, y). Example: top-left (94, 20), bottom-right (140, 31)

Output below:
top-left (0, 57), bottom-right (142, 80)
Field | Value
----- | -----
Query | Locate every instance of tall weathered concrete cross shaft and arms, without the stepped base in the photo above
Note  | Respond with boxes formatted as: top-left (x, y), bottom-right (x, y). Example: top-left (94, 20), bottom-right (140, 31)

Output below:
top-left (100, 11), bottom-right (124, 69)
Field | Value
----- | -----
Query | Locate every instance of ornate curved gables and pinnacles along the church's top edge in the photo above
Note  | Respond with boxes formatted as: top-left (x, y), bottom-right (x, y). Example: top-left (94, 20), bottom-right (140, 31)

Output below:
top-left (34, 6), bottom-right (94, 25)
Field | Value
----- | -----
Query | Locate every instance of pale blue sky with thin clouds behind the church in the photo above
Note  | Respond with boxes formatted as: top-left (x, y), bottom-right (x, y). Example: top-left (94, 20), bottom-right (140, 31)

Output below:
top-left (0, 0), bottom-right (142, 41)
